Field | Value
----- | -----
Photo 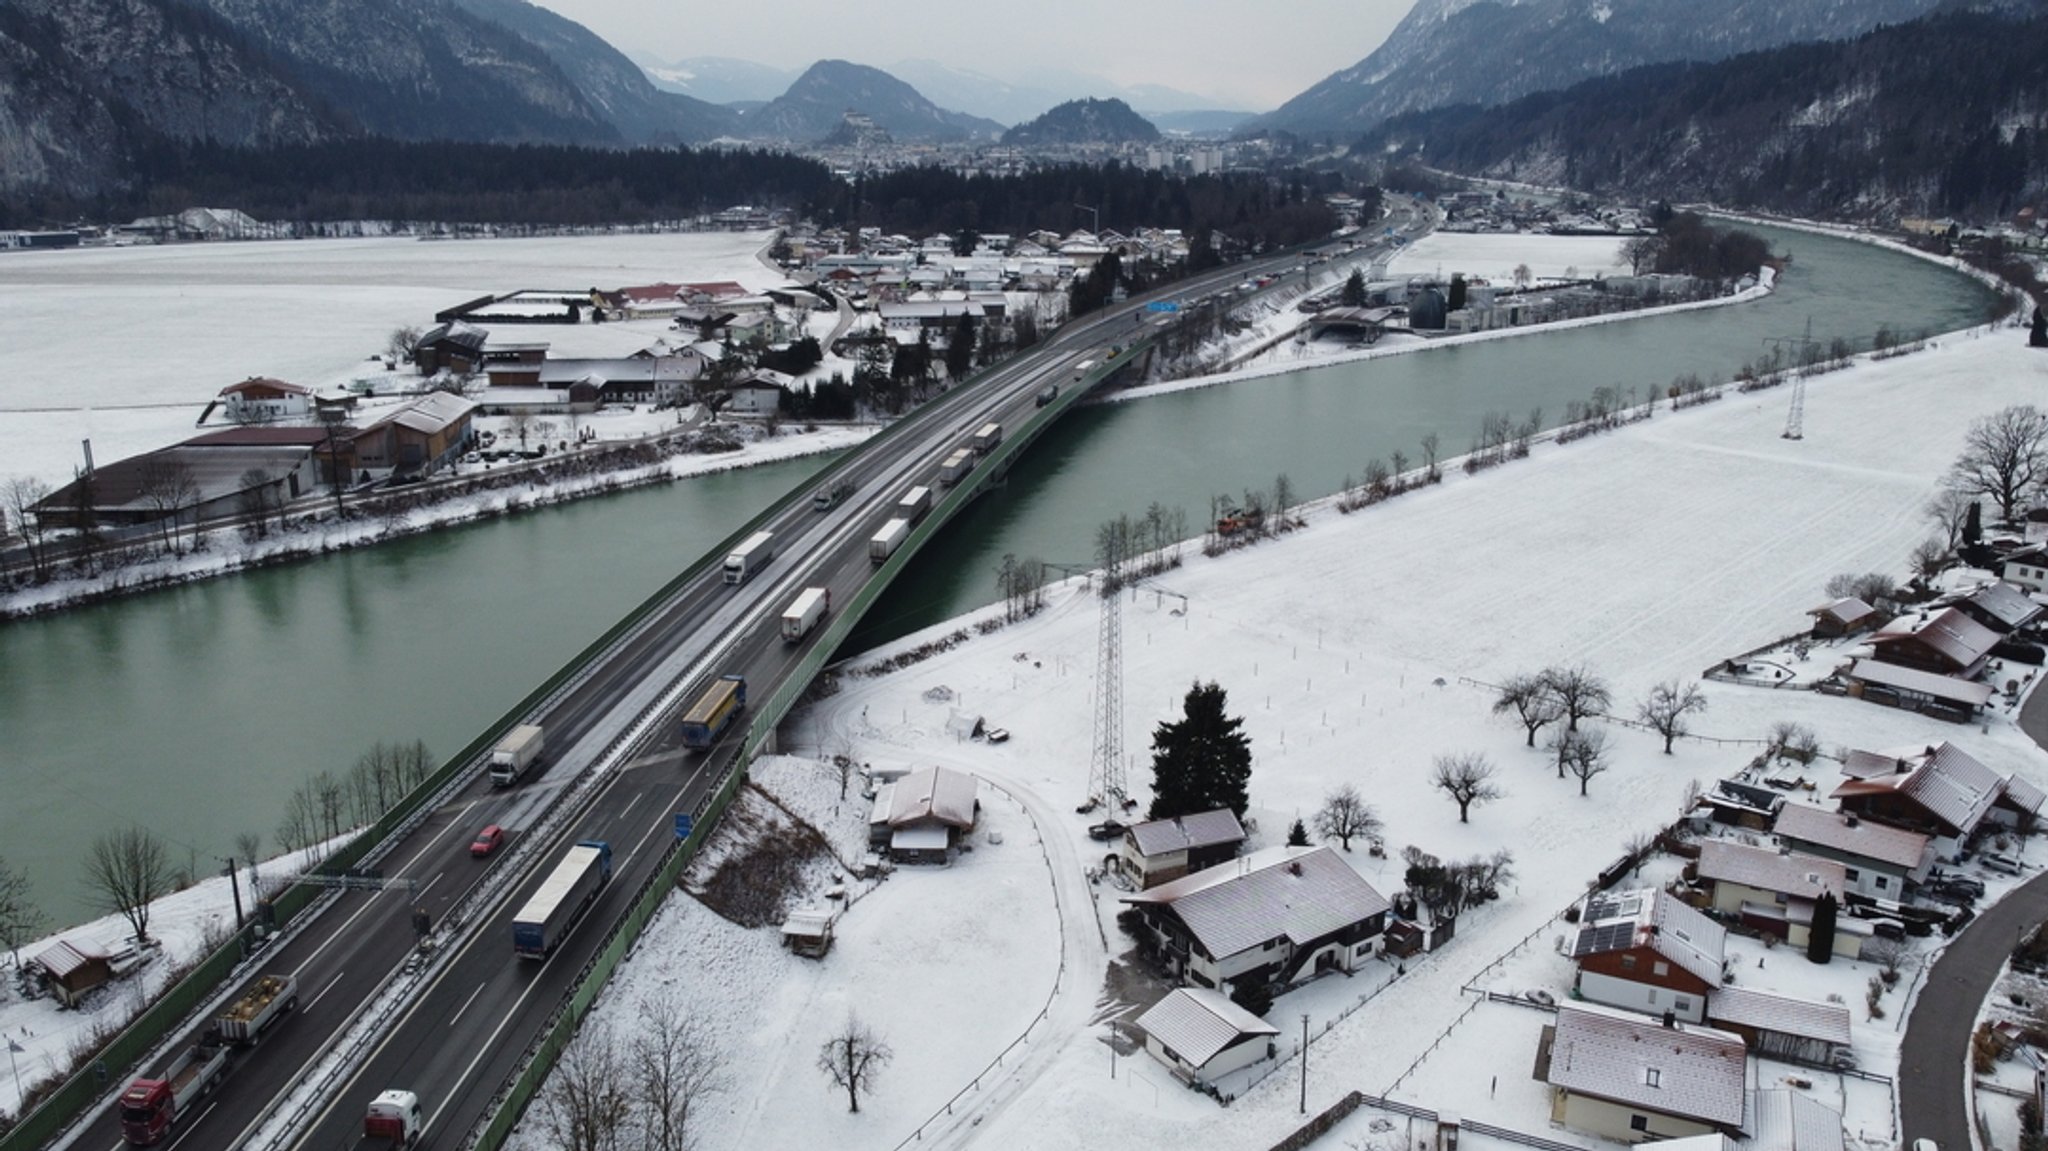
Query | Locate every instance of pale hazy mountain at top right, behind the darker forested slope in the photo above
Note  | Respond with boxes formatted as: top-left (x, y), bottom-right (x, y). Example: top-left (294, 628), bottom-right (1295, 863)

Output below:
top-left (1245, 0), bottom-right (1942, 133)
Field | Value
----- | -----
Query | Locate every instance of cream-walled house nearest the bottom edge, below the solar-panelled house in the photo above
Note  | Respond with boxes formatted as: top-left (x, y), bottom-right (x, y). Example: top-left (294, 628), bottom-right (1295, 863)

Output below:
top-left (1536, 1004), bottom-right (1749, 1143)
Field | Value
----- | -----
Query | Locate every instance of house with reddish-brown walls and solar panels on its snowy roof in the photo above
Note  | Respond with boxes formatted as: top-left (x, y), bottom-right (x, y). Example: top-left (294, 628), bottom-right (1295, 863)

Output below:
top-left (1571, 887), bottom-right (1729, 1022)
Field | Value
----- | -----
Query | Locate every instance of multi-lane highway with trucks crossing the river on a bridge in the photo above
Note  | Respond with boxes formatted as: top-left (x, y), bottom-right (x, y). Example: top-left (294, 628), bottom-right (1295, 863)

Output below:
top-left (68, 209), bottom-right (1427, 1151)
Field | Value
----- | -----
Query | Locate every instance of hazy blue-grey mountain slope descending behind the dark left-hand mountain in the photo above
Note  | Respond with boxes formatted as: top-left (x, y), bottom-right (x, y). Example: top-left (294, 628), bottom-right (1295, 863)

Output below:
top-left (451, 0), bottom-right (739, 143)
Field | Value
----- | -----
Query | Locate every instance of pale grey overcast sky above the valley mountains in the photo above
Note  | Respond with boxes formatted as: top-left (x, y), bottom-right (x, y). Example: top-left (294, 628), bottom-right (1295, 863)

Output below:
top-left (537, 0), bottom-right (1415, 111)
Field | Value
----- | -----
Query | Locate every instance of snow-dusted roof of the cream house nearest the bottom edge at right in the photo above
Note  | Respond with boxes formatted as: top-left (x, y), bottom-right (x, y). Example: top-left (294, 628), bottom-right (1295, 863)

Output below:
top-left (1546, 1004), bottom-right (1747, 1126)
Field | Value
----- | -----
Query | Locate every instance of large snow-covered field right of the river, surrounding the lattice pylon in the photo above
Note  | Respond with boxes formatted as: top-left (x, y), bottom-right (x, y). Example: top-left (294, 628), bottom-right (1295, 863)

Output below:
top-left (532, 317), bottom-right (2048, 1147)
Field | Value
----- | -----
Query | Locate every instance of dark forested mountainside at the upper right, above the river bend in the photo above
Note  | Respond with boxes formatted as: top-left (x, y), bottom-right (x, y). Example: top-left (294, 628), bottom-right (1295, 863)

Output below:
top-left (1356, 4), bottom-right (2048, 221)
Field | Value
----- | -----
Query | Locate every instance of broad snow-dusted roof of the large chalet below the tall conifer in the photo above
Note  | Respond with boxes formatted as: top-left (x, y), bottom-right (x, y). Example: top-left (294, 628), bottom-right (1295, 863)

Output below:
top-left (1122, 843), bottom-right (1393, 958)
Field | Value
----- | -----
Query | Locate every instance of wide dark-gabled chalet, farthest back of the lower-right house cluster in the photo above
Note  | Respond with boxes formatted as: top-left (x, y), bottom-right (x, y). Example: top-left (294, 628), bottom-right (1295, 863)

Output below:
top-left (1829, 741), bottom-right (2048, 856)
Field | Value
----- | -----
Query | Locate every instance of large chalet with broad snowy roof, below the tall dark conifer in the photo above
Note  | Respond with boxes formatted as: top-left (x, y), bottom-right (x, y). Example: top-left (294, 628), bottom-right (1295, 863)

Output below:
top-left (1122, 848), bottom-right (1391, 993)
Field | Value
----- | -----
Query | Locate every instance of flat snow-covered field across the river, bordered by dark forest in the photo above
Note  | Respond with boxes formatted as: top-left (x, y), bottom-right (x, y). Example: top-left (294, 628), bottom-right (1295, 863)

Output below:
top-left (0, 231), bottom-right (780, 485)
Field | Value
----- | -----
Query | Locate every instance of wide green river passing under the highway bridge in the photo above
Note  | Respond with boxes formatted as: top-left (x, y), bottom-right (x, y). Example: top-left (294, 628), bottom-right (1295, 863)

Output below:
top-left (0, 229), bottom-right (1989, 924)
